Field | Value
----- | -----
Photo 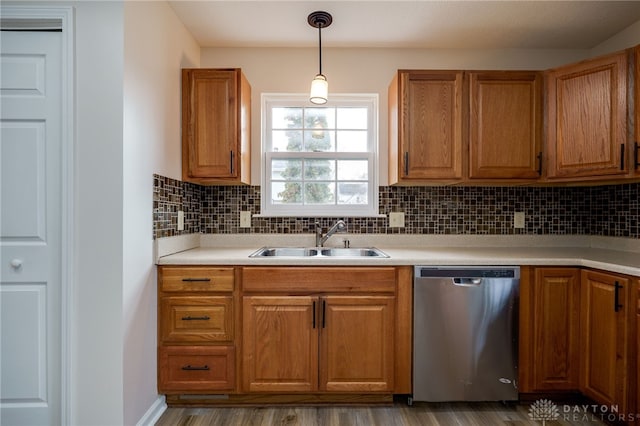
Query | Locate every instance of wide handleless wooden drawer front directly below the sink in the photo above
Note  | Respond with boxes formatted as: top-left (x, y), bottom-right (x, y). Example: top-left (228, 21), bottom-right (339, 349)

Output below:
top-left (242, 267), bottom-right (396, 293)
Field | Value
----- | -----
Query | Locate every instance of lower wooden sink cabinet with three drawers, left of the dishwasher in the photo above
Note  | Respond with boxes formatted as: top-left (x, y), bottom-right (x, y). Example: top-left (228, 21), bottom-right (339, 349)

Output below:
top-left (158, 266), bottom-right (413, 404)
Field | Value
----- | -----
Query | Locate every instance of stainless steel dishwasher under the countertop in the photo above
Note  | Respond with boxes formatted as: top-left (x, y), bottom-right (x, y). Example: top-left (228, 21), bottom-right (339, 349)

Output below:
top-left (409, 266), bottom-right (520, 404)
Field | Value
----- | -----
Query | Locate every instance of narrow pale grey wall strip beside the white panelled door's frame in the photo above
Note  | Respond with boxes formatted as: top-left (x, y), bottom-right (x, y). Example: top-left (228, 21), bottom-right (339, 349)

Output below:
top-left (70, 2), bottom-right (124, 425)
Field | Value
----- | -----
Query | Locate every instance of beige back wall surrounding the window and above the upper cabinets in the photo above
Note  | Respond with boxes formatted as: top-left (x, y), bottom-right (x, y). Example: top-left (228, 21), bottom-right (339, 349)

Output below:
top-left (202, 48), bottom-right (590, 185)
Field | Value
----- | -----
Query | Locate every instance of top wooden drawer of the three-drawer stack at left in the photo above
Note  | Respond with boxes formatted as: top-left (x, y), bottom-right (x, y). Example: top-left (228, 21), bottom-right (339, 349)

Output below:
top-left (158, 266), bottom-right (234, 292)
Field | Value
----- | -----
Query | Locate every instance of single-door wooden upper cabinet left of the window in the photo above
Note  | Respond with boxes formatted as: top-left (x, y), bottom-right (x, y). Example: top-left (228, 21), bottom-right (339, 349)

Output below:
top-left (182, 68), bottom-right (251, 185)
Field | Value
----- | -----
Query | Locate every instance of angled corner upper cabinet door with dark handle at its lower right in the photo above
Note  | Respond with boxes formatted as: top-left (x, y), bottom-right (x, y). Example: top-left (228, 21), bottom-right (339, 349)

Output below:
top-left (547, 52), bottom-right (628, 178)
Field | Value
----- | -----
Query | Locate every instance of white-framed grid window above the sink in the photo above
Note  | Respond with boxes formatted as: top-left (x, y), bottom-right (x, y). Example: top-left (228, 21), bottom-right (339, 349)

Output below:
top-left (261, 95), bottom-right (378, 216)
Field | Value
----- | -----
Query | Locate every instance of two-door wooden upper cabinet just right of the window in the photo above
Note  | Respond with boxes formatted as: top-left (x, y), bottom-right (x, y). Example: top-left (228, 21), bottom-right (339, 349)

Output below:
top-left (389, 70), bottom-right (542, 184)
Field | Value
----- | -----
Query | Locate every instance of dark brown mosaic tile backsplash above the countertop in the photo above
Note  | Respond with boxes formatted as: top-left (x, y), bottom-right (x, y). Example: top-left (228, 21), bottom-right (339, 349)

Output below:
top-left (153, 175), bottom-right (640, 238)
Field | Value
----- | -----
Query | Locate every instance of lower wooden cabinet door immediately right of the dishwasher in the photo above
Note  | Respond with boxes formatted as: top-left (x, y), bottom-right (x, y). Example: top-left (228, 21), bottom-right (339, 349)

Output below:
top-left (520, 268), bottom-right (580, 392)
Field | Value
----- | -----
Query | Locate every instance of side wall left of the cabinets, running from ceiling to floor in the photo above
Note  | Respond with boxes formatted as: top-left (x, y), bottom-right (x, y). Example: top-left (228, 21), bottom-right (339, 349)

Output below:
top-left (122, 1), bottom-right (200, 425)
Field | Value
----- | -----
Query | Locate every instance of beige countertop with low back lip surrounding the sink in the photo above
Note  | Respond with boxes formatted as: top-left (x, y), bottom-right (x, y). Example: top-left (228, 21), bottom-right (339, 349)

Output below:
top-left (156, 234), bottom-right (640, 277)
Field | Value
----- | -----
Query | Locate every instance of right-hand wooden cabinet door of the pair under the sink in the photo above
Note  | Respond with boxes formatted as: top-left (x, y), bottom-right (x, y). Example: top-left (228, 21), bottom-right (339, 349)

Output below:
top-left (320, 296), bottom-right (395, 392)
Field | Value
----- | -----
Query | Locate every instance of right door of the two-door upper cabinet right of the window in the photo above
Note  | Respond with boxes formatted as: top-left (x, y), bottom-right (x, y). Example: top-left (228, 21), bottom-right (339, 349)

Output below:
top-left (469, 71), bottom-right (542, 179)
